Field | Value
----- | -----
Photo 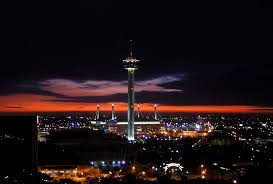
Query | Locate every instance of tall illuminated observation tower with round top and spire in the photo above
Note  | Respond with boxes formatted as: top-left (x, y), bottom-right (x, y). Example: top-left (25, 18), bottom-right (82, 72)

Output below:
top-left (123, 42), bottom-right (139, 141)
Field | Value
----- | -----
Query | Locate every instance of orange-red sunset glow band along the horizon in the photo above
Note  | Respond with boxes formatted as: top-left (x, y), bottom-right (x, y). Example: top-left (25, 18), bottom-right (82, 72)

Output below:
top-left (0, 94), bottom-right (273, 113)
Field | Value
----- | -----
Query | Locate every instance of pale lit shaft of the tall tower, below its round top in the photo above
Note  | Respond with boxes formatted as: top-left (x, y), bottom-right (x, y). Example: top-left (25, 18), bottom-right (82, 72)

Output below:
top-left (128, 68), bottom-right (135, 140)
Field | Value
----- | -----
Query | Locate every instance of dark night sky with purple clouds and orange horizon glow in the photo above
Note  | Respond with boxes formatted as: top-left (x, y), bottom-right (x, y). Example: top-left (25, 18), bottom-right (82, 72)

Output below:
top-left (0, 0), bottom-right (273, 113)
